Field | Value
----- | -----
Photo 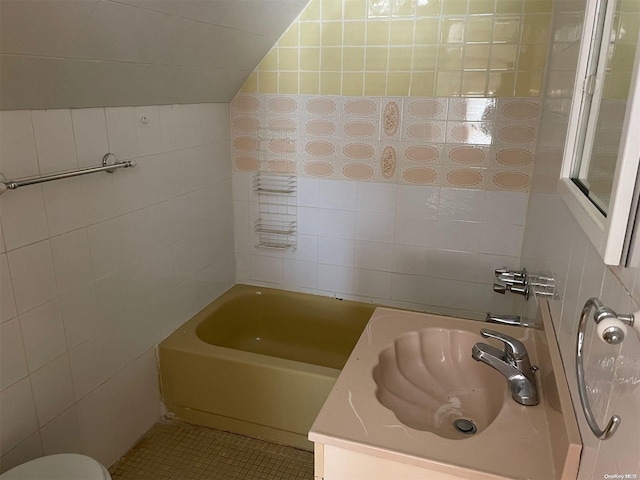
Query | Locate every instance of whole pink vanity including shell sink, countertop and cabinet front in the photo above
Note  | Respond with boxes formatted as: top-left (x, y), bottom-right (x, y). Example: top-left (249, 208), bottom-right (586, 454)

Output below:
top-left (309, 300), bottom-right (582, 480)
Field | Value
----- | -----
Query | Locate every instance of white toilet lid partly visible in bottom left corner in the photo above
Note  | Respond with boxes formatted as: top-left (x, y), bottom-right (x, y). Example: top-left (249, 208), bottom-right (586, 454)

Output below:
top-left (0, 453), bottom-right (111, 480)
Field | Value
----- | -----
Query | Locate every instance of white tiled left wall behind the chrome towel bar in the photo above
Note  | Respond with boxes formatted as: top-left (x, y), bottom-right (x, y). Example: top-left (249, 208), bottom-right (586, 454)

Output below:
top-left (0, 104), bottom-right (235, 471)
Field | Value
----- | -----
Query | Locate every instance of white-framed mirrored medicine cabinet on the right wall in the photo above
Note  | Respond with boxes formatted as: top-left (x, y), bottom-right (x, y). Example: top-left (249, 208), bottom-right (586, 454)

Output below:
top-left (558, 0), bottom-right (640, 265)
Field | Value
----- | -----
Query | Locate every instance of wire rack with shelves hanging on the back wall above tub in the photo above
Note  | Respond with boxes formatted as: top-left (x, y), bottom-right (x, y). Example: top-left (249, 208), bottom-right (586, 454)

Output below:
top-left (253, 130), bottom-right (298, 250)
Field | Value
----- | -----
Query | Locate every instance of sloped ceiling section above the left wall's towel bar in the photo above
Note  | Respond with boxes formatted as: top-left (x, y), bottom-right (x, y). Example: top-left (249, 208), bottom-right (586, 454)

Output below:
top-left (0, 0), bottom-right (308, 110)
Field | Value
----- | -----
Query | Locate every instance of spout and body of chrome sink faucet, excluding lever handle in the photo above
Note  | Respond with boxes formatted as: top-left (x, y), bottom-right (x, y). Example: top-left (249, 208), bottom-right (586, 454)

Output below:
top-left (471, 343), bottom-right (540, 405)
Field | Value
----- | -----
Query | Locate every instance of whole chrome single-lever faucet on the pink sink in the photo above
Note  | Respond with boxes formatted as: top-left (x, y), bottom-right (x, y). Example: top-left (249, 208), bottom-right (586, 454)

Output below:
top-left (471, 328), bottom-right (540, 405)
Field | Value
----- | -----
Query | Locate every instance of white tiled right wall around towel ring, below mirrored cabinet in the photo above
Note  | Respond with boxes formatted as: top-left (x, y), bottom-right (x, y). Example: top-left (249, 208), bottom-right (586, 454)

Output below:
top-left (523, 193), bottom-right (640, 479)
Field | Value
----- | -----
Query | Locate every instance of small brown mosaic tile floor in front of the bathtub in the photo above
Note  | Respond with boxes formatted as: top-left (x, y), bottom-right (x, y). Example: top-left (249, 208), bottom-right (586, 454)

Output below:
top-left (109, 420), bottom-right (313, 480)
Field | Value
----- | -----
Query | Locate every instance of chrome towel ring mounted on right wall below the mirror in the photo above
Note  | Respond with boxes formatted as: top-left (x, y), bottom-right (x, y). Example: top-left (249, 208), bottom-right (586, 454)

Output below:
top-left (576, 297), bottom-right (640, 440)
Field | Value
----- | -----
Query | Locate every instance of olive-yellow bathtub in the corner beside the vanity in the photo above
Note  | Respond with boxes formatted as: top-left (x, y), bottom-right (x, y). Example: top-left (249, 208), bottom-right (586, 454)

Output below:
top-left (159, 285), bottom-right (375, 450)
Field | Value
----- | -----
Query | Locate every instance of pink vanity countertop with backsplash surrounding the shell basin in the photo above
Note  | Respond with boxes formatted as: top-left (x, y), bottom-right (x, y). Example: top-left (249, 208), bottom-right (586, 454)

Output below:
top-left (309, 301), bottom-right (581, 480)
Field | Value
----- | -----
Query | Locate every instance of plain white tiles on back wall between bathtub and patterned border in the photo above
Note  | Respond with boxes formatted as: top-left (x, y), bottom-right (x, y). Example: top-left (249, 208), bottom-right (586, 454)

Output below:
top-left (233, 176), bottom-right (528, 318)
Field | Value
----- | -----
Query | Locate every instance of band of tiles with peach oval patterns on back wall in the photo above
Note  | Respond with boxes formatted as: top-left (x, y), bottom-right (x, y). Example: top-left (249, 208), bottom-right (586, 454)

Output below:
top-left (231, 94), bottom-right (540, 191)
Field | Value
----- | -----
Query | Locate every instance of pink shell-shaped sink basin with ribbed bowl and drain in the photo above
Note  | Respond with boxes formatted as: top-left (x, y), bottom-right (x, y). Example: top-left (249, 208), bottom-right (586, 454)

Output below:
top-left (373, 328), bottom-right (511, 439)
